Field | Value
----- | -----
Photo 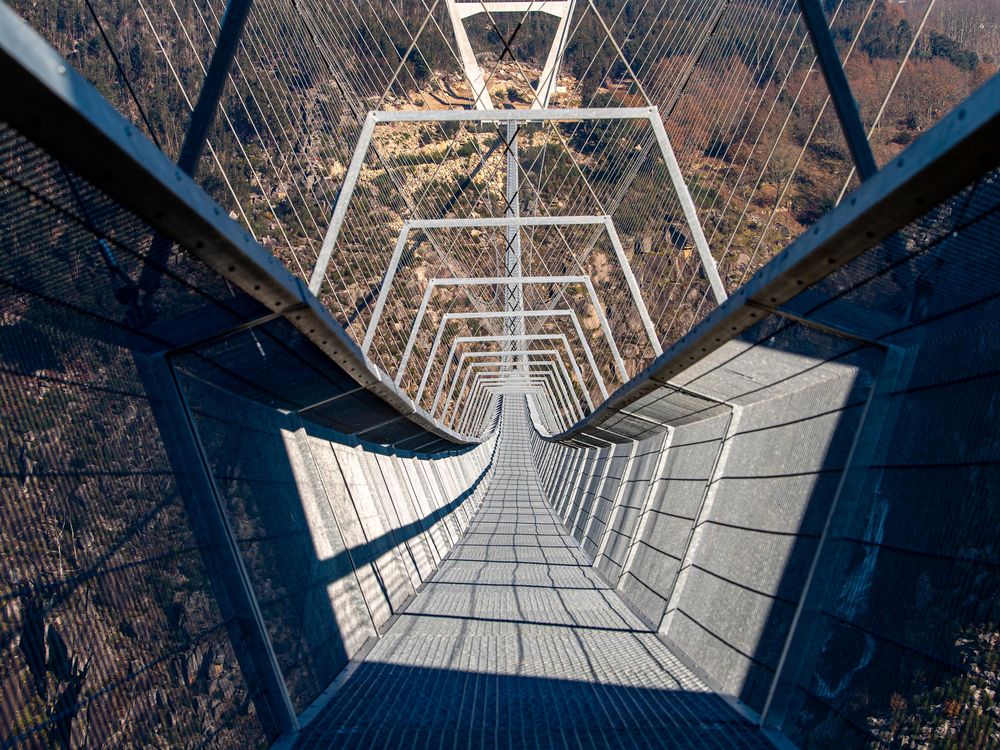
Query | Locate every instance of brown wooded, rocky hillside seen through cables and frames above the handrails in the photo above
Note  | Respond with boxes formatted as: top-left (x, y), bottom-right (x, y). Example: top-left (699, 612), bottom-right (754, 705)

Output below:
top-left (9, 0), bottom-right (989, 432)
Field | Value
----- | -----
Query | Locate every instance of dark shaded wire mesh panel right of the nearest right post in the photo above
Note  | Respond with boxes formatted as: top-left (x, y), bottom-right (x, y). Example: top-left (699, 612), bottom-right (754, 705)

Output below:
top-left (764, 167), bottom-right (1000, 747)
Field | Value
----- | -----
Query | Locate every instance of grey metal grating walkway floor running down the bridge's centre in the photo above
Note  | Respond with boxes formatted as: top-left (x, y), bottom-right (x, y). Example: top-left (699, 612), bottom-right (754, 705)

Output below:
top-left (296, 404), bottom-right (771, 748)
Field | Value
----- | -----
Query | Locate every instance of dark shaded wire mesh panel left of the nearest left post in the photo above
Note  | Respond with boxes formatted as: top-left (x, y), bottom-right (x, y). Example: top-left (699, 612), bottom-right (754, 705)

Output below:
top-left (0, 122), bottom-right (270, 747)
